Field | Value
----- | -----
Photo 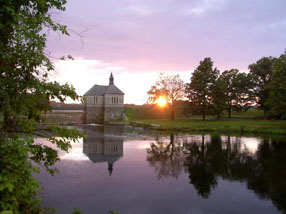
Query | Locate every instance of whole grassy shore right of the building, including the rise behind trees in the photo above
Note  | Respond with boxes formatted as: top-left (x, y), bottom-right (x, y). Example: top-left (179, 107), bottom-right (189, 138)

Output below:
top-left (125, 103), bottom-right (286, 135)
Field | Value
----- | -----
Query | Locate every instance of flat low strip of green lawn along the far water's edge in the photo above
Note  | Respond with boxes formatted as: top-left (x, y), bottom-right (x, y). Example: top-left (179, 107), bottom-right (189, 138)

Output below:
top-left (131, 119), bottom-right (286, 135)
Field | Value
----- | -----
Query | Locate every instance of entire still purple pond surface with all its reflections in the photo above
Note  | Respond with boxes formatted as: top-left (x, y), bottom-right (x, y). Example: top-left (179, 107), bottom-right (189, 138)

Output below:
top-left (37, 126), bottom-right (286, 214)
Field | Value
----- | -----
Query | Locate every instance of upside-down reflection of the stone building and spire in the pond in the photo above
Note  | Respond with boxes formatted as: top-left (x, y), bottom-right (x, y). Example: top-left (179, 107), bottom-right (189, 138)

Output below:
top-left (83, 125), bottom-right (123, 175)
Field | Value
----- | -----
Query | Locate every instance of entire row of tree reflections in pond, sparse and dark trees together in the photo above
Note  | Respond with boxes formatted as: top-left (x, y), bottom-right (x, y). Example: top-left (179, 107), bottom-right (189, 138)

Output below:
top-left (147, 134), bottom-right (286, 213)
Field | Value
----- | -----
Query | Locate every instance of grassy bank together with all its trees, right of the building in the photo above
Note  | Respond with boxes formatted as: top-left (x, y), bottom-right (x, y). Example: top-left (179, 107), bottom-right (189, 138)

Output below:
top-left (135, 51), bottom-right (286, 135)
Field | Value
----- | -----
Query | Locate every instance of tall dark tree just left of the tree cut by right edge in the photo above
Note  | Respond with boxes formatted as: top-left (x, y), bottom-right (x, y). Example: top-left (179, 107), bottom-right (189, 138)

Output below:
top-left (249, 57), bottom-right (275, 119)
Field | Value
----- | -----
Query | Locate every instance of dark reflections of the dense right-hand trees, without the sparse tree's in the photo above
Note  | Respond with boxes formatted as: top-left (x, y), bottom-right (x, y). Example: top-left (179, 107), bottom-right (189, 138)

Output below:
top-left (185, 136), bottom-right (286, 212)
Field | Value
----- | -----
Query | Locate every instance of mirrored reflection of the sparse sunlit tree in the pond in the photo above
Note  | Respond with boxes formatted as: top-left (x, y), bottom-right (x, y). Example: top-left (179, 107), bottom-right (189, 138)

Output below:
top-left (147, 134), bottom-right (184, 179)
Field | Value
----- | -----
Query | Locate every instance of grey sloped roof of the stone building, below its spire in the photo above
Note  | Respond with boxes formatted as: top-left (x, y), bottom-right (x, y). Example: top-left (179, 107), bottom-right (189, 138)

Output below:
top-left (84, 85), bottom-right (124, 96)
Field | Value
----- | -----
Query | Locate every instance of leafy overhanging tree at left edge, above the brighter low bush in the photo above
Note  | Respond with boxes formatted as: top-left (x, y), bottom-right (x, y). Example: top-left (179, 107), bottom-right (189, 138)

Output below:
top-left (0, 0), bottom-right (79, 131)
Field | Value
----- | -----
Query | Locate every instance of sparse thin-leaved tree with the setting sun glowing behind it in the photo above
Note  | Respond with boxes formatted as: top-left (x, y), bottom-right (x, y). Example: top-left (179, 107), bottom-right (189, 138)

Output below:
top-left (147, 73), bottom-right (185, 120)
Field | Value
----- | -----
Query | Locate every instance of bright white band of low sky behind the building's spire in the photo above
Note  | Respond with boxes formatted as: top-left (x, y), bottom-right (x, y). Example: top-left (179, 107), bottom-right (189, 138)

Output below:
top-left (51, 58), bottom-right (192, 105)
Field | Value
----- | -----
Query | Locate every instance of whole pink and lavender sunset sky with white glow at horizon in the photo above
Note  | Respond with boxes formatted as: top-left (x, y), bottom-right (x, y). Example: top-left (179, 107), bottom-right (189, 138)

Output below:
top-left (47, 0), bottom-right (286, 104)
